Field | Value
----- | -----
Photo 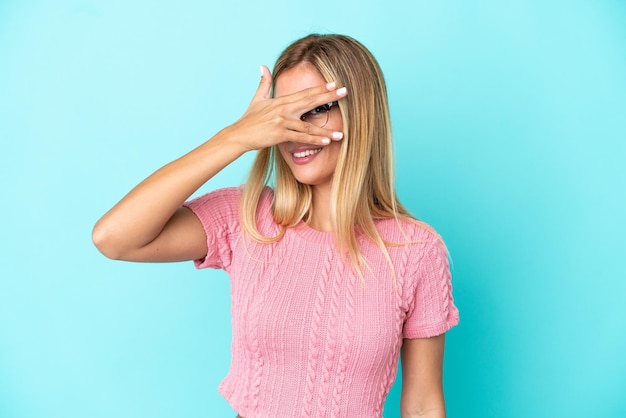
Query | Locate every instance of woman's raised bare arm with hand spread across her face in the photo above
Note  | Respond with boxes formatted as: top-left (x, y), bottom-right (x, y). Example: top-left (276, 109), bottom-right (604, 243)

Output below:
top-left (92, 67), bottom-right (345, 261)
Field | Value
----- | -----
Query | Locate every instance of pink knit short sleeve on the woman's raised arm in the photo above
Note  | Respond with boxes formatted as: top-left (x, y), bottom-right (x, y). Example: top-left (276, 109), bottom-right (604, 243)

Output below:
top-left (183, 187), bottom-right (241, 269)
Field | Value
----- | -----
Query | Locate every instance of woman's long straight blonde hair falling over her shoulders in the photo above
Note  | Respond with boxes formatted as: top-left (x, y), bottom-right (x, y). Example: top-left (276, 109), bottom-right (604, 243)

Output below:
top-left (242, 34), bottom-right (411, 275)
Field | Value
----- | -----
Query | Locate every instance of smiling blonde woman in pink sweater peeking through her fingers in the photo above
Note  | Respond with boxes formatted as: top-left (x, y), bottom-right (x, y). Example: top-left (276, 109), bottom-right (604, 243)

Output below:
top-left (93, 35), bottom-right (458, 418)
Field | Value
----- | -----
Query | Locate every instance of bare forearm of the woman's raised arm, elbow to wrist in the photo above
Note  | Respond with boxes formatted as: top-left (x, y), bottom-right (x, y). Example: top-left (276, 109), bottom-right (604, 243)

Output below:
top-left (93, 128), bottom-right (245, 258)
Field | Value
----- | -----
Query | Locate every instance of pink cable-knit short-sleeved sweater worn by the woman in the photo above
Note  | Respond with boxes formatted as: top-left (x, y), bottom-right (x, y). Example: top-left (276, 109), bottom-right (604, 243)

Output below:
top-left (186, 188), bottom-right (459, 418)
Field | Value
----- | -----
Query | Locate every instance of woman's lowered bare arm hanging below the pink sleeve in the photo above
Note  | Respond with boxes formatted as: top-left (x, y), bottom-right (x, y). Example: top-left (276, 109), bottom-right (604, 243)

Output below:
top-left (400, 334), bottom-right (446, 418)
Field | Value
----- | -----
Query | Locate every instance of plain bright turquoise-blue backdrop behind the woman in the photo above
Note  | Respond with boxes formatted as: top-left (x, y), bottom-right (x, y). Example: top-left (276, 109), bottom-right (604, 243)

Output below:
top-left (0, 0), bottom-right (626, 418)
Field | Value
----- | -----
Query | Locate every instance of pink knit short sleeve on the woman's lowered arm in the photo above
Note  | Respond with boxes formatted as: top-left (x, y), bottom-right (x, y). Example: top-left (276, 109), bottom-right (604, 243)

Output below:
top-left (403, 237), bottom-right (459, 338)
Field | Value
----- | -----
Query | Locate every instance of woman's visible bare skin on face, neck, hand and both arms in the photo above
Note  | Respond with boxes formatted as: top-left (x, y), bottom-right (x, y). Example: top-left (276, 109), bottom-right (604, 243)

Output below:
top-left (92, 64), bottom-right (445, 418)
